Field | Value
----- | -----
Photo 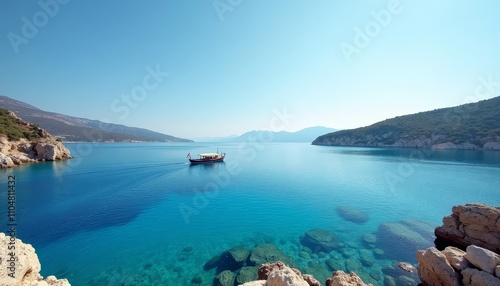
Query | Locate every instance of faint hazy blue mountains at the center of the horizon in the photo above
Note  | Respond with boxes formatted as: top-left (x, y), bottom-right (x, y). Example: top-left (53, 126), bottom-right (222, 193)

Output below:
top-left (227, 126), bottom-right (336, 143)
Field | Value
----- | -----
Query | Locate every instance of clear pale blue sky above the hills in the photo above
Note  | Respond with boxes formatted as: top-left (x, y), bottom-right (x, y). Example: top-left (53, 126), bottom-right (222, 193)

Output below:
top-left (0, 0), bottom-right (500, 138)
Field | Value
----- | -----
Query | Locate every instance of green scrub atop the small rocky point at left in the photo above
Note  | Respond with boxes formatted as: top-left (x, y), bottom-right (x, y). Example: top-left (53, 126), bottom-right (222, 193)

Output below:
top-left (0, 109), bottom-right (45, 141)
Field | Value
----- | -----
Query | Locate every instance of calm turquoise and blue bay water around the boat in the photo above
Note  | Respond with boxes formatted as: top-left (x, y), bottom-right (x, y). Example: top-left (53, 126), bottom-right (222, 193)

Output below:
top-left (0, 143), bottom-right (500, 285)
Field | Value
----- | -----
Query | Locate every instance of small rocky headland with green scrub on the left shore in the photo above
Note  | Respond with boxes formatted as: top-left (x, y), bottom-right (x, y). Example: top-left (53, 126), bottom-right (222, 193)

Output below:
top-left (0, 109), bottom-right (72, 168)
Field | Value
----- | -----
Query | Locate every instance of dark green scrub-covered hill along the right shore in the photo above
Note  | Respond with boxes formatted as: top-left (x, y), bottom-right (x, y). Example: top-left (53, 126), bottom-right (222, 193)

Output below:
top-left (312, 97), bottom-right (500, 150)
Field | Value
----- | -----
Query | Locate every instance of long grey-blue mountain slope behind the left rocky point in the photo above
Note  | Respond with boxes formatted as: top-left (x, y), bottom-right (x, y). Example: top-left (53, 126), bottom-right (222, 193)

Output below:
top-left (0, 96), bottom-right (192, 142)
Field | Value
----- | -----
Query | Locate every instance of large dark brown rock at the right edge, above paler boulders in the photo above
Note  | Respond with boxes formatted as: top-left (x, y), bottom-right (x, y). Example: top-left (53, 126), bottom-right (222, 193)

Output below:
top-left (435, 203), bottom-right (500, 253)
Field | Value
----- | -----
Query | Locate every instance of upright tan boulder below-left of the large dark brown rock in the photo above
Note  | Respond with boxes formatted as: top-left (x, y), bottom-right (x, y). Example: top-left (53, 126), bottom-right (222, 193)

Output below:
top-left (417, 247), bottom-right (460, 286)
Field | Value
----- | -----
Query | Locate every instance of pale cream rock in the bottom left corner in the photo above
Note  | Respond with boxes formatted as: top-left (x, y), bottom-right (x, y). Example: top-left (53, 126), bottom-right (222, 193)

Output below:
top-left (0, 233), bottom-right (71, 286)
